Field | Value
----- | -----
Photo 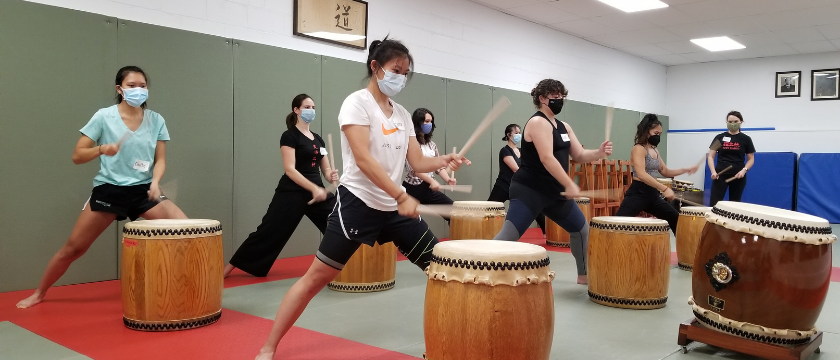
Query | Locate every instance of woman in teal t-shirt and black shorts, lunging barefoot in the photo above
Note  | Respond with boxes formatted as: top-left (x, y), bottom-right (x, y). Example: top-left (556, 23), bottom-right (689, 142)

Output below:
top-left (17, 66), bottom-right (187, 308)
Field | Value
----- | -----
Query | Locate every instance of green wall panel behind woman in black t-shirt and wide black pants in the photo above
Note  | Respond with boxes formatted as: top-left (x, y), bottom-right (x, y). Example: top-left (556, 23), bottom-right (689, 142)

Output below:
top-left (233, 40), bottom-right (324, 258)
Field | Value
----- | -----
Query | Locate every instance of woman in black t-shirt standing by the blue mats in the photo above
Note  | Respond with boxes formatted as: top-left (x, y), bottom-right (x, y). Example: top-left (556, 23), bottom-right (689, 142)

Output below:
top-left (707, 111), bottom-right (755, 206)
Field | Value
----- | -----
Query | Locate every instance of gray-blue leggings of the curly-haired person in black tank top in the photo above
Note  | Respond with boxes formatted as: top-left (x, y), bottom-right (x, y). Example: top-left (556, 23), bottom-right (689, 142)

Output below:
top-left (494, 180), bottom-right (589, 275)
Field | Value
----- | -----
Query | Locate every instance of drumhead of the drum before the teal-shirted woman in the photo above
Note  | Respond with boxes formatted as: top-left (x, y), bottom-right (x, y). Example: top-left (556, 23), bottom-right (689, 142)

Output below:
top-left (123, 219), bottom-right (222, 239)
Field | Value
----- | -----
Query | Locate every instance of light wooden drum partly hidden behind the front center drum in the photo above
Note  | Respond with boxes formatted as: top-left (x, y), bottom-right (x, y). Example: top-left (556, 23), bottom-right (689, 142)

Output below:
top-left (449, 201), bottom-right (505, 240)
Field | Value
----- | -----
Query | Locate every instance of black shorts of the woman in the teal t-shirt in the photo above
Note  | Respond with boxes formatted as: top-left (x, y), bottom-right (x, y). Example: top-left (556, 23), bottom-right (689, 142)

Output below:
top-left (88, 184), bottom-right (166, 221)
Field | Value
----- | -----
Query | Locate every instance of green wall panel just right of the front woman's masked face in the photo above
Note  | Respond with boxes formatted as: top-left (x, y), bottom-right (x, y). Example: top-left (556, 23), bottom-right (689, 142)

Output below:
top-left (394, 74), bottom-right (458, 238)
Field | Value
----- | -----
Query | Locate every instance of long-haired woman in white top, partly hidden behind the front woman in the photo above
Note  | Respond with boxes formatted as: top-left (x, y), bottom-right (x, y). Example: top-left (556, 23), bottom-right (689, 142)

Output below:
top-left (403, 108), bottom-right (456, 221)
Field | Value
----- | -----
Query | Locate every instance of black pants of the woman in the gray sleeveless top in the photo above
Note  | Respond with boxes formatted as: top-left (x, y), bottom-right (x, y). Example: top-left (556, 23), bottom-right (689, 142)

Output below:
top-left (615, 181), bottom-right (680, 234)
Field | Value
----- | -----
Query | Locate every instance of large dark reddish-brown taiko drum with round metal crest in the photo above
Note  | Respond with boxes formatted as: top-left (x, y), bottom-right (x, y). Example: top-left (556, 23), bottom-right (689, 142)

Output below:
top-left (689, 201), bottom-right (837, 346)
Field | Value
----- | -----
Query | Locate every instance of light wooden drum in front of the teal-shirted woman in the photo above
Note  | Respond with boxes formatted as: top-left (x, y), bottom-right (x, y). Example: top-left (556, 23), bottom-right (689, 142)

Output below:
top-left (120, 219), bottom-right (225, 331)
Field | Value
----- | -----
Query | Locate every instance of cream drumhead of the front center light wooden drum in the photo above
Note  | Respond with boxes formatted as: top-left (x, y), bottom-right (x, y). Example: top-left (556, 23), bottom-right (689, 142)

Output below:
top-left (426, 240), bottom-right (554, 286)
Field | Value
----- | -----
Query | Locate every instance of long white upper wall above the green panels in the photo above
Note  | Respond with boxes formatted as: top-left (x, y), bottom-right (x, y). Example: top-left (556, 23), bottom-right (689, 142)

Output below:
top-left (26, 0), bottom-right (665, 113)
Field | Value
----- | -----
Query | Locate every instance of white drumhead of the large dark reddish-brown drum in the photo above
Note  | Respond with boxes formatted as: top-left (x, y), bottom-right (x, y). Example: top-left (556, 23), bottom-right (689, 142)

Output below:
top-left (708, 201), bottom-right (837, 245)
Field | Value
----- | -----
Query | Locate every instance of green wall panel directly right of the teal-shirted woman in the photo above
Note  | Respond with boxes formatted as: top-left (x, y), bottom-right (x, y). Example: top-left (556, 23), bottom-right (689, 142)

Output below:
top-left (113, 20), bottom-right (236, 254)
